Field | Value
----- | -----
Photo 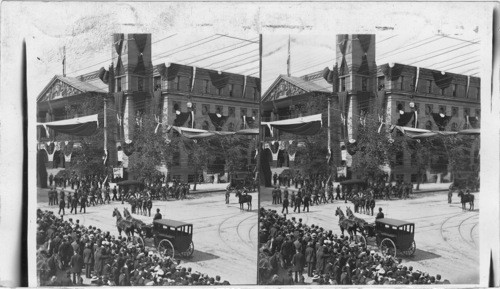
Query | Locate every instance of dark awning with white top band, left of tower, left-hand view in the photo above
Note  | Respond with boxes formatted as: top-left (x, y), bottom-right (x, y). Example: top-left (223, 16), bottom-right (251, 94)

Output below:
top-left (37, 114), bottom-right (99, 136)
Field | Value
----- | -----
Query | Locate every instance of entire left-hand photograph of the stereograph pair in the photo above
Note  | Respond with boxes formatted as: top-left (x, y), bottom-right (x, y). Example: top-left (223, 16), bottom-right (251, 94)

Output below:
top-left (33, 32), bottom-right (261, 286)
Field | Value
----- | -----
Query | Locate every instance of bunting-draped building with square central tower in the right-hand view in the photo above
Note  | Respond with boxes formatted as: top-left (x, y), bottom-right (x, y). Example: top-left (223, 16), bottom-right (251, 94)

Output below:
top-left (261, 34), bottom-right (481, 181)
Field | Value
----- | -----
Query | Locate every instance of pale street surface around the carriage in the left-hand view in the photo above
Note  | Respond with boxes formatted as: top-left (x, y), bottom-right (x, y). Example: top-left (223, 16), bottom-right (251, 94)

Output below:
top-left (38, 190), bottom-right (258, 284)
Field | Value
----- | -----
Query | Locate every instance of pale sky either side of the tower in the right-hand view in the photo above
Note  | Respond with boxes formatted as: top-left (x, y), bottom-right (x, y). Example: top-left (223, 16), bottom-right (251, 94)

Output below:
top-left (262, 30), bottom-right (481, 92)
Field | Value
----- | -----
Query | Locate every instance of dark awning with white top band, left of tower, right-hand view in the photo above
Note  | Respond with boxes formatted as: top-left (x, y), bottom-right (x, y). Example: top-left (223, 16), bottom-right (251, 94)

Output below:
top-left (260, 114), bottom-right (323, 135)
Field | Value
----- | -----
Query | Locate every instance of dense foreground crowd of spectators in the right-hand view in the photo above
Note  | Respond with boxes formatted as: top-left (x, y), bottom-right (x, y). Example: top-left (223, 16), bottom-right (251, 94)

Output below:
top-left (259, 208), bottom-right (450, 285)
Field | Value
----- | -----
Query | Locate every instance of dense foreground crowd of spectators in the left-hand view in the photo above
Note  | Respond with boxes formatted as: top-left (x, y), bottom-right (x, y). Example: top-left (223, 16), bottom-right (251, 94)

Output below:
top-left (36, 209), bottom-right (230, 286)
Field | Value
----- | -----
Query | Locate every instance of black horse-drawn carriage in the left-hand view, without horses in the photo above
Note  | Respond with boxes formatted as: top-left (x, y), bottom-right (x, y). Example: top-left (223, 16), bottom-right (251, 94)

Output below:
top-left (143, 219), bottom-right (194, 258)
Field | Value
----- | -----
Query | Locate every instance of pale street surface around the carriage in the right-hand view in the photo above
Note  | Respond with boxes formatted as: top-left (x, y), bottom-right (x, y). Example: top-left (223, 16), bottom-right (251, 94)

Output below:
top-left (260, 187), bottom-right (479, 284)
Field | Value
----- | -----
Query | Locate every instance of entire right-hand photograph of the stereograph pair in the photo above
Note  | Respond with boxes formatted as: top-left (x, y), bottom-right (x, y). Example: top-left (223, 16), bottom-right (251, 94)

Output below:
top-left (258, 31), bottom-right (481, 286)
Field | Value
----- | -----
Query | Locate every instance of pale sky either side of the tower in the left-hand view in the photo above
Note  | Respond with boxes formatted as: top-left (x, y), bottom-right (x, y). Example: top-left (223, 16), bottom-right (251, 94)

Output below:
top-left (29, 33), bottom-right (259, 95)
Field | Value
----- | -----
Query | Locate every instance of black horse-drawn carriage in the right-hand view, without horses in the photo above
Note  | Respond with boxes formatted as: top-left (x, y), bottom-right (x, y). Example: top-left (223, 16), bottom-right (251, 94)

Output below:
top-left (368, 218), bottom-right (417, 257)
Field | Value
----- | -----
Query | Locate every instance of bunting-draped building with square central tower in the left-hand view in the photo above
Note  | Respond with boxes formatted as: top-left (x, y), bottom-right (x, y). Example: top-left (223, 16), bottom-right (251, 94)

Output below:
top-left (37, 34), bottom-right (260, 181)
